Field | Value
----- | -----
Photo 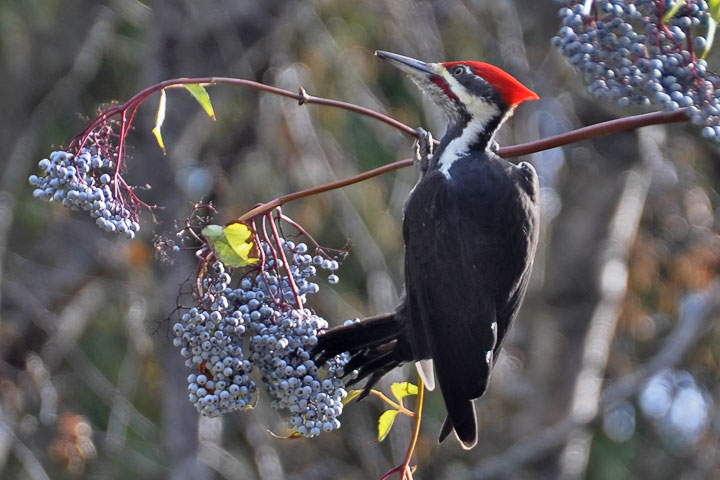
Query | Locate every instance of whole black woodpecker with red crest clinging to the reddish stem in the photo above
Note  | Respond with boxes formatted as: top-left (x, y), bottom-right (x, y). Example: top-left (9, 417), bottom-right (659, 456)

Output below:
top-left (315, 51), bottom-right (539, 449)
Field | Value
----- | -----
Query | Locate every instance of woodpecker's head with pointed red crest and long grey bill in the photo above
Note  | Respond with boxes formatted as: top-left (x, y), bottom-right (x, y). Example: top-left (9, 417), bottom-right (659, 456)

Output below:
top-left (375, 50), bottom-right (539, 123)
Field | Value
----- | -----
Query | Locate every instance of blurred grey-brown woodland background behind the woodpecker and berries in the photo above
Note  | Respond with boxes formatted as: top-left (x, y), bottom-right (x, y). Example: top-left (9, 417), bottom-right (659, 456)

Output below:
top-left (0, 0), bottom-right (720, 479)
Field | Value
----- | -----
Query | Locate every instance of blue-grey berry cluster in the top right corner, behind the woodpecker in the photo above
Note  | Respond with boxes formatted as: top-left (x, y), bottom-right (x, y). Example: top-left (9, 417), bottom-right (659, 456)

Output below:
top-left (553, 0), bottom-right (720, 141)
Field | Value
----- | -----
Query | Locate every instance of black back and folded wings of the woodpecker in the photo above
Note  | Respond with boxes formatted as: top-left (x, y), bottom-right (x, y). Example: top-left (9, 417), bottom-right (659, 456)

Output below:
top-left (404, 160), bottom-right (537, 448)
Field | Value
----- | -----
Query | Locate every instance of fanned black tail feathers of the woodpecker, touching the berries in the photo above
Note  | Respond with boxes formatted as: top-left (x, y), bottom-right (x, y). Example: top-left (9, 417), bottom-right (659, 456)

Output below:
top-left (314, 309), bottom-right (413, 400)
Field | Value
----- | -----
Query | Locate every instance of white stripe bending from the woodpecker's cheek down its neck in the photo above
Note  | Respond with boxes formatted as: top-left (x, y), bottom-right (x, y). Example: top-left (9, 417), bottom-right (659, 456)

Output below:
top-left (438, 70), bottom-right (500, 178)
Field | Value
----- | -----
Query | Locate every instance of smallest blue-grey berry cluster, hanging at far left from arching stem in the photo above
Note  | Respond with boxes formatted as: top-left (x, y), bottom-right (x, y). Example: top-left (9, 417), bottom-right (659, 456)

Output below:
top-left (28, 146), bottom-right (140, 238)
